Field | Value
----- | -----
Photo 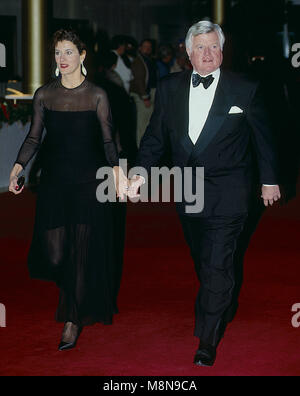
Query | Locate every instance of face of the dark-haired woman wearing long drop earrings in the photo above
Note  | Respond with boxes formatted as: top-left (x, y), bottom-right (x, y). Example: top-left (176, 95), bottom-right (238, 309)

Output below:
top-left (55, 40), bottom-right (85, 75)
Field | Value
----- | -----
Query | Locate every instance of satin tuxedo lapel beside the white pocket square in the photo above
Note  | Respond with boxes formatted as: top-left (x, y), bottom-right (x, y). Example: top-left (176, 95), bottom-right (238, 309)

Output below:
top-left (192, 71), bottom-right (236, 158)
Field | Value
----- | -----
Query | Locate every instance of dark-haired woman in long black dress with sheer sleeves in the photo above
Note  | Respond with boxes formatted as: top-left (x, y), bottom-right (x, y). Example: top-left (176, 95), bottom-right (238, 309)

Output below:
top-left (9, 30), bottom-right (128, 350)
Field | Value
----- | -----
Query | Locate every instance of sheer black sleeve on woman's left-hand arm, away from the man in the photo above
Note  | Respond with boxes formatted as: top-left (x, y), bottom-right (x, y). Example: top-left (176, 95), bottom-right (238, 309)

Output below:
top-left (15, 88), bottom-right (44, 169)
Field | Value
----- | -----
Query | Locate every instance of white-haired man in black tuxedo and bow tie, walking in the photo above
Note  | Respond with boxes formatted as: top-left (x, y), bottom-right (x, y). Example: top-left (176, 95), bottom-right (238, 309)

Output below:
top-left (128, 21), bottom-right (280, 366)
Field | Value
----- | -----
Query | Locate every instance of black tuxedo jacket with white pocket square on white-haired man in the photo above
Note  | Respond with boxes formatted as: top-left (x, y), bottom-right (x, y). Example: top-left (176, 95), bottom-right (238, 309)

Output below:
top-left (137, 70), bottom-right (278, 216)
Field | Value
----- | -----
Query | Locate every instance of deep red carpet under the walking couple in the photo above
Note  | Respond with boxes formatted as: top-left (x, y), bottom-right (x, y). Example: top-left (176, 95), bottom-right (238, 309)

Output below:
top-left (0, 187), bottom-right (300, 376)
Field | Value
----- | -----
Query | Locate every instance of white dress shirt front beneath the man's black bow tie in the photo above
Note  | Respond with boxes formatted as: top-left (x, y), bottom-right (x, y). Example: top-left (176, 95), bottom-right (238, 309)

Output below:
top-left (189, 69), bottom-right (220, 144)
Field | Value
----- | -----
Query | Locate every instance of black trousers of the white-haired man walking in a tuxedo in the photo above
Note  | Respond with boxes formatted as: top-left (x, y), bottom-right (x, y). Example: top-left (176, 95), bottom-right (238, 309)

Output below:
top-left (180, 213), bottom-right (247, 346)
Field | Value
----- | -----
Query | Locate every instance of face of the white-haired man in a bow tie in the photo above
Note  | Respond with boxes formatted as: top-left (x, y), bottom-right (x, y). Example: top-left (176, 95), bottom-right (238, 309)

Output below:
top-left (187, 32), bottom-right (223, 76)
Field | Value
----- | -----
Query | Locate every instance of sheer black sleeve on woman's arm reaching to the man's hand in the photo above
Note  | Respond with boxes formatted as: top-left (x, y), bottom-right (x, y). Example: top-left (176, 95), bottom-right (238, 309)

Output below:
top-left (97, 90), bottom-right (119, 167)
